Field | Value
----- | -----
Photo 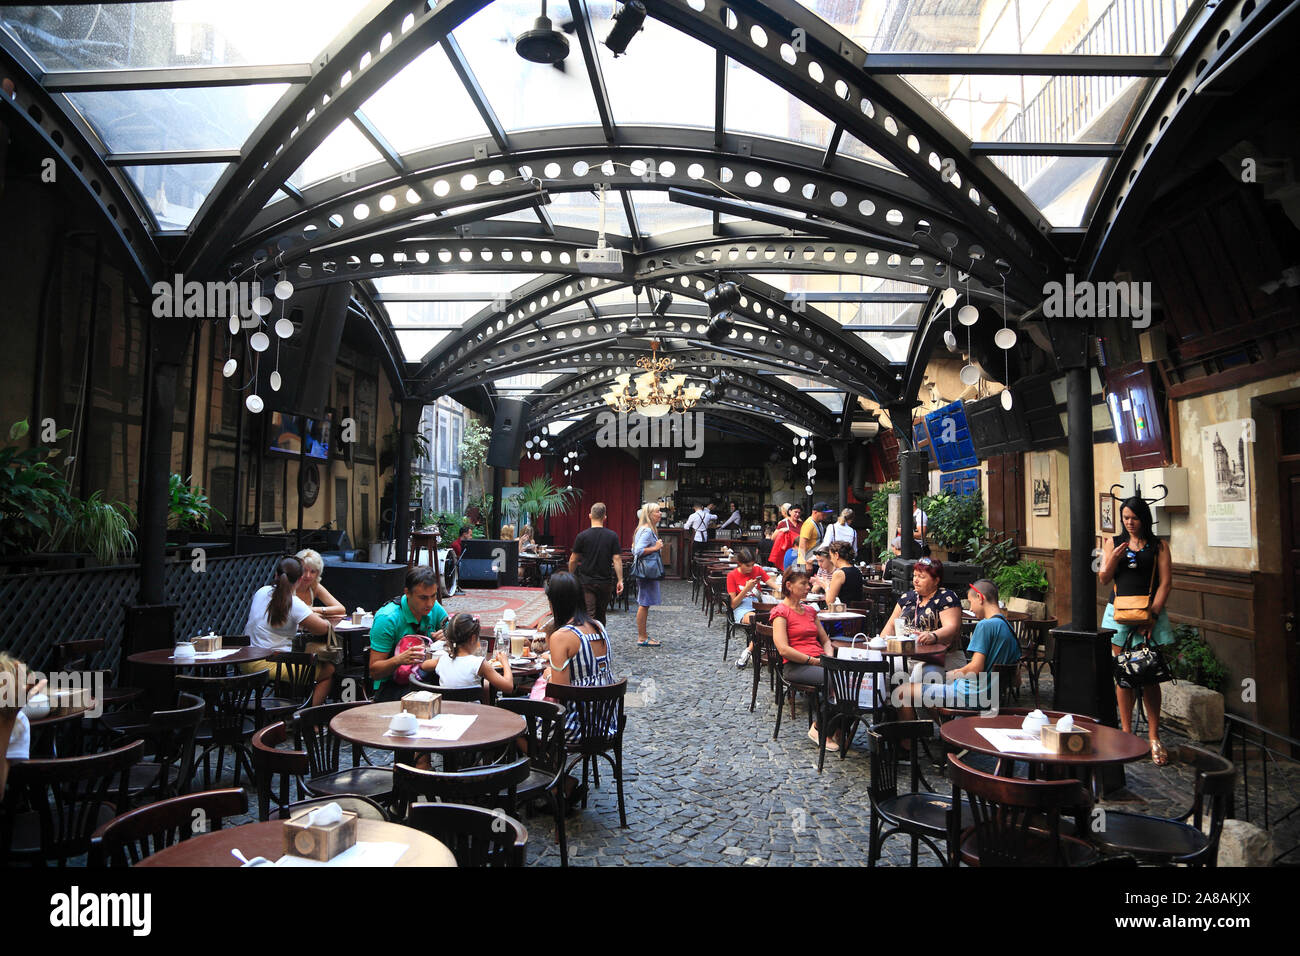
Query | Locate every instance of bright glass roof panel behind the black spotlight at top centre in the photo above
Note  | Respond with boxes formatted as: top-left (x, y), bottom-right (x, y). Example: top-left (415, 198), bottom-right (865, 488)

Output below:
top-left (588, 1), bottom-right (716, 127)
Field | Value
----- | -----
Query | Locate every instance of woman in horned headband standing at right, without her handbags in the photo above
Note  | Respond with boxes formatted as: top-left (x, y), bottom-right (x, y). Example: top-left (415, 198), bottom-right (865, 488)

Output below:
top-left (1099, 498), bottom-right (1174, 766)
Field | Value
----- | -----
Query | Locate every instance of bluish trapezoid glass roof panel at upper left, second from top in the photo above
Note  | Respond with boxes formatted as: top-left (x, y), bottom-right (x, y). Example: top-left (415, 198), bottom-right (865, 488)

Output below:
top-left (68, 83), bottom-right (289, 152)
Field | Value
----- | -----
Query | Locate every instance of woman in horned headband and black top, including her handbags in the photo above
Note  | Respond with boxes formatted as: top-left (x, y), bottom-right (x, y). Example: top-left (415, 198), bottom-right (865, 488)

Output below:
top-left (1100, 497), bottom-right (1174, 766)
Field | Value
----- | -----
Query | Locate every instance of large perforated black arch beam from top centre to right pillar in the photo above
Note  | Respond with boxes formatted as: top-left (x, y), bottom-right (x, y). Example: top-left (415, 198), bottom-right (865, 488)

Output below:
top-left (646, 0), bottom-right (1065, 284)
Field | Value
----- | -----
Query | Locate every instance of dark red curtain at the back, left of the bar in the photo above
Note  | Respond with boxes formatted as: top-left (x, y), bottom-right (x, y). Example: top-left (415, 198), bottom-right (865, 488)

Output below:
top-left (516, 447), bottom-right (642, 548)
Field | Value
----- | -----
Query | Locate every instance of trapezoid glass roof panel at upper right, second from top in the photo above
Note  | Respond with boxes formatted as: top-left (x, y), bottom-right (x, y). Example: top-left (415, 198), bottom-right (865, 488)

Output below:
top-left (905, 74), bottom-right (1145, 143)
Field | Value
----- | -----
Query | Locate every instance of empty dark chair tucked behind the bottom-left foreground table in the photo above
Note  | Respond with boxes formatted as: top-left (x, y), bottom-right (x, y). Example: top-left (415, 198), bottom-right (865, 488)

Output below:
top-left (88, 787), bottom-right (248, 866)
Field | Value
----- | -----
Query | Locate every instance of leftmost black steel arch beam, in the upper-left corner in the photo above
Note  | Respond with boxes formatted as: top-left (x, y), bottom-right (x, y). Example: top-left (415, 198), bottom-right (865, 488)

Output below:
top-left (0, 42), bottom-right (164, 295)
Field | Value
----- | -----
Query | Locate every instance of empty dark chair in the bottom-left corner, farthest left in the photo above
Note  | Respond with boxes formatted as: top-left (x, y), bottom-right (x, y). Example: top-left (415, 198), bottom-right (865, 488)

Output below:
top-left (0, 740), bottom-right (144, 866)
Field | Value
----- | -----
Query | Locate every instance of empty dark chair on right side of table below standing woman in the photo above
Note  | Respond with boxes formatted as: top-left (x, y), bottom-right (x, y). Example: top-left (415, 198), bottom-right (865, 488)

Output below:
top-left (1092, 744), bottom-right (1236, 866)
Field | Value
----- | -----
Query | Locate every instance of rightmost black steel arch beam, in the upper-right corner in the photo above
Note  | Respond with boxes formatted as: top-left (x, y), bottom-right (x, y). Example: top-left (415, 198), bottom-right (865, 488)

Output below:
top-left (1076, 0), bottom-right (1294, 281)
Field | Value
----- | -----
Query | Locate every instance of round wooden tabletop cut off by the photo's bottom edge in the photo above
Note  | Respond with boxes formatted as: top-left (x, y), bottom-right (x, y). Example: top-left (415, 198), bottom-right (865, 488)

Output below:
top-left (135, 819), bottom-right (456, 866)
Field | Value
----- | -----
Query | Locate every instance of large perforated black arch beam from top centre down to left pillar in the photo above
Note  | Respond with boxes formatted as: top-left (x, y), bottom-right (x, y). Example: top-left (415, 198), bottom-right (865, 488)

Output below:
top-left (179, 0), bottom-right (490, 278)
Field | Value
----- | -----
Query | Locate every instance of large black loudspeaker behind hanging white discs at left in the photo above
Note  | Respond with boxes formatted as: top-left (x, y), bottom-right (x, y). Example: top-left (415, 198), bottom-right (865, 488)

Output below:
top-left (257, 282), bottom-right (352, 419)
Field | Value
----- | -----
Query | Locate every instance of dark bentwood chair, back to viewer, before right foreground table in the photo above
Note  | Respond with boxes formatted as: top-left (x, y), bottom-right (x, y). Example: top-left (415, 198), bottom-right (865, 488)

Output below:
top-left (948, 754), bottom-right (1097, 866)
